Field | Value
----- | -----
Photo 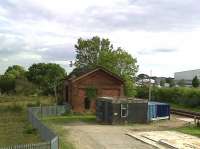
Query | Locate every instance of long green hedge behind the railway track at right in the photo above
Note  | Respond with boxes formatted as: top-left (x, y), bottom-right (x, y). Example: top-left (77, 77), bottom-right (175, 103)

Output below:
top-left (136, 86), bottom-right (200, 107)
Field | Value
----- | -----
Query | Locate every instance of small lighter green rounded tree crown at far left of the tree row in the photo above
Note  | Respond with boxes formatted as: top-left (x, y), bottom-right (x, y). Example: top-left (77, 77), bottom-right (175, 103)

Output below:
top-left (4, 65), bottom-right (26, 79)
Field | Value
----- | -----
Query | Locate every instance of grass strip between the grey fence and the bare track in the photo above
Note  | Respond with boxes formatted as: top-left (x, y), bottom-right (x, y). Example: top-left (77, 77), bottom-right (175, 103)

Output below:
top-left (43, 115), bottom-right (96, 149)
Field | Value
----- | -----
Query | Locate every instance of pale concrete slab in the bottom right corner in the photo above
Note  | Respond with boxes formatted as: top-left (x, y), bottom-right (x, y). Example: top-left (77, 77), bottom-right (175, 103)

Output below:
top-left (126, 131), bottom-right (200, 149)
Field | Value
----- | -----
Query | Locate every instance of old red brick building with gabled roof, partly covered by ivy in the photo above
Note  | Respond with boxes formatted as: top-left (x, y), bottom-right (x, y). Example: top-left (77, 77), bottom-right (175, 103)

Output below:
top-left (64, 67), bottom-right (124, 112)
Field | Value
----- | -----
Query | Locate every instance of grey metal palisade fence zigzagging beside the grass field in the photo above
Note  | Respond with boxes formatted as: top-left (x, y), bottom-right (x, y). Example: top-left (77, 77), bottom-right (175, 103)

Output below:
top-left (0, 105), bottom-right (70, 149)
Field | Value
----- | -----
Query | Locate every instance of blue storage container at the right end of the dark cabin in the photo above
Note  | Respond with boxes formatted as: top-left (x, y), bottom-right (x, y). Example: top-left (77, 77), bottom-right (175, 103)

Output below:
top-left (148, 102), bottom-right (170, 121)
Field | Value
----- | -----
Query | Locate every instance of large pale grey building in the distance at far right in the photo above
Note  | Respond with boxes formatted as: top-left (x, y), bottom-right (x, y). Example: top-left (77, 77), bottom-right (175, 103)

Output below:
top-left (174, 69), bottom-right (200, 86)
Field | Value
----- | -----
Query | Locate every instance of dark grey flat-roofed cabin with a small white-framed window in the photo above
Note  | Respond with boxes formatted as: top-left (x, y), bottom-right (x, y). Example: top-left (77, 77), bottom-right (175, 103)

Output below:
top-left (96, 97), bottom-right (148, 124)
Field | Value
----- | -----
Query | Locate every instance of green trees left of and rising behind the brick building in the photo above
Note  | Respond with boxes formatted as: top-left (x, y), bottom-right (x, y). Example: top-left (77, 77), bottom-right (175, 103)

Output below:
top-left (0, 36), bottom-right (138, 97)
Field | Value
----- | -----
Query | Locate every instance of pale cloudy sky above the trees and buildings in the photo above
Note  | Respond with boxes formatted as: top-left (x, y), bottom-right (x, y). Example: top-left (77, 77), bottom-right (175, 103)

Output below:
top-left (0, 0), bottom-right (200, 77)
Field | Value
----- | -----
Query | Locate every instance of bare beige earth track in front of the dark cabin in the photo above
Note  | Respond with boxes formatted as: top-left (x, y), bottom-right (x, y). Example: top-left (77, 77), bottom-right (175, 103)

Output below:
top-left (64, 116), bottom-right (186, 149)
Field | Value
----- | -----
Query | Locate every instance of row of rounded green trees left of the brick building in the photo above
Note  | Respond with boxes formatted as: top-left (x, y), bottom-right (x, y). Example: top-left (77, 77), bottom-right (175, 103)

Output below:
top-left (0, 63), bottom-right (66, 95)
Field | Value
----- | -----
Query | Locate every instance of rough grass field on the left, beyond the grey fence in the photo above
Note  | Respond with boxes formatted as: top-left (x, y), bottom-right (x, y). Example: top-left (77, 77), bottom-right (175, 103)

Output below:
top-left (0, 96), bottom-right (53, 146)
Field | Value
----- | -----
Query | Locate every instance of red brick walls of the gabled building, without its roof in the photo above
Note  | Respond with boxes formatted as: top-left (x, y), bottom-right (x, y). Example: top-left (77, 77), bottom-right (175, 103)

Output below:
top-left (70, 71), bottom-right (123, 112)
